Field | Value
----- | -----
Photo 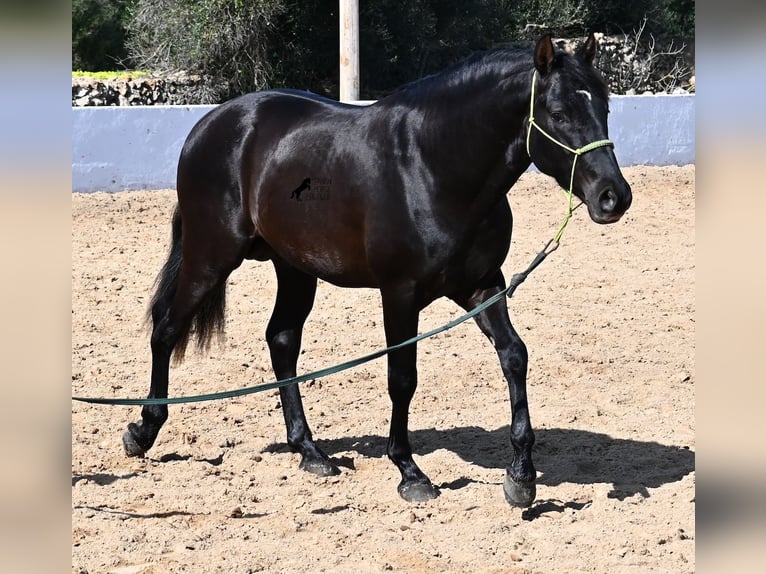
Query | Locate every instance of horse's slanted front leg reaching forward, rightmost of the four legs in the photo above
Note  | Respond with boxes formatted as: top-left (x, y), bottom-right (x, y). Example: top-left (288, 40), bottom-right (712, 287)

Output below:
top-left (454, 271), bottom-right (536, 507)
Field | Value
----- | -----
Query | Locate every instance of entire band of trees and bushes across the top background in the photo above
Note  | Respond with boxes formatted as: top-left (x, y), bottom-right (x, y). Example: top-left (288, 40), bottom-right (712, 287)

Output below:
top-left (72, 0), bottom-right (695, 102)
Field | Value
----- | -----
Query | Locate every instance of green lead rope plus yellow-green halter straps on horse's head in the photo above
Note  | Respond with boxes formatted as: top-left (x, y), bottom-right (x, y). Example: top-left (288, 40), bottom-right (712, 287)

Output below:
top-left (72, 72), bottom-right (613, 405)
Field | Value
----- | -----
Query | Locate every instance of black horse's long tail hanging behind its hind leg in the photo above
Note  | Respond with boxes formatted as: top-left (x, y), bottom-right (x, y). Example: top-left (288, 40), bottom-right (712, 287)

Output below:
top-left (147, 205), bottom-right (226, 363)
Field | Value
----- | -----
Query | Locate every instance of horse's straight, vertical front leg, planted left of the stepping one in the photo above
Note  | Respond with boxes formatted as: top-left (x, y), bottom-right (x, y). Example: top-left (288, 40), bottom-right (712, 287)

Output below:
top-left (381, 288), bottom-right (439, 502)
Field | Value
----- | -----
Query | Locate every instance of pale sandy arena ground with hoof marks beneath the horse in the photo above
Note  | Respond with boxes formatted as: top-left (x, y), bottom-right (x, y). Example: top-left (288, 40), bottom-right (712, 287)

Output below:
top-left (72, 166), bottom-right (695, 574)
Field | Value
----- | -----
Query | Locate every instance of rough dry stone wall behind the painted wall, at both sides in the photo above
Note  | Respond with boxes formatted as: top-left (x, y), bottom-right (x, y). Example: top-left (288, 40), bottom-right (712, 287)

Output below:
top-left (72, 34), bottom-right (694, 107)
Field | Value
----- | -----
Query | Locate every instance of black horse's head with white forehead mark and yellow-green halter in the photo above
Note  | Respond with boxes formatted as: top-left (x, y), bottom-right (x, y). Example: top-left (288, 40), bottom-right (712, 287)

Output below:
top-left (526, 34), bottom-right (632, 223)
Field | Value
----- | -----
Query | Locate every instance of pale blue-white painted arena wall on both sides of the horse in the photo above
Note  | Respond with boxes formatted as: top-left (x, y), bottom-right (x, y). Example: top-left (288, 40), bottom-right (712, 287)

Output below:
top-left (72, 95), bottom-right (694, 192)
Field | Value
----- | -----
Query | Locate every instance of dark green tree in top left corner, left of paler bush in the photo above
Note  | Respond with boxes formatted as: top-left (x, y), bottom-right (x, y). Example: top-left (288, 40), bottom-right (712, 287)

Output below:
top-left (72, 0), bottom-right (132, 71)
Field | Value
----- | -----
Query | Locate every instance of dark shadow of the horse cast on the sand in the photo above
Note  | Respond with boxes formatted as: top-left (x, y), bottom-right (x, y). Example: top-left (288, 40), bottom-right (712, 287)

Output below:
top-left (274, 425), bottom-right (695, 500)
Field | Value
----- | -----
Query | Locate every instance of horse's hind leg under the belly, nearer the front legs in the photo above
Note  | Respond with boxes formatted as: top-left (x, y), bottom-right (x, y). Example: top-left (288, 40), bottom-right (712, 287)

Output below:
top-left (266, 259), bottom-right (340, 476)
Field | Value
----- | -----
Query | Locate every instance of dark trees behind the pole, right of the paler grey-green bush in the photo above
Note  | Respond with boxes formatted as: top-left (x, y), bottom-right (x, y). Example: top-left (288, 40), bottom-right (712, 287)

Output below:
top-left (269, 0), bottom-right (694, 99)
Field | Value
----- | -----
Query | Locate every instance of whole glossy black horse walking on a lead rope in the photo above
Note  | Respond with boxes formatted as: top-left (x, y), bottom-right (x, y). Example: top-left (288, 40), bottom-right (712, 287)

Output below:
top-left (123, 35), bottom-right (631, 506)
